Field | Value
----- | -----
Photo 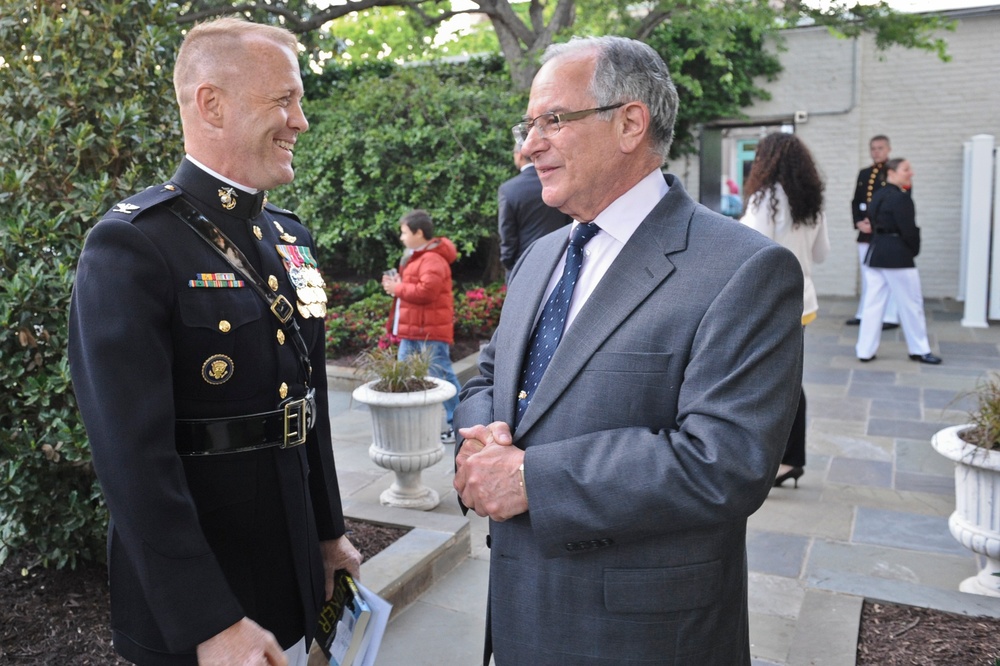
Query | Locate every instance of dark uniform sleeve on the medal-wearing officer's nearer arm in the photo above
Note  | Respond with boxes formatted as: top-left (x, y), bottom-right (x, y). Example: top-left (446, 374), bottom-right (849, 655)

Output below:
top-left (69, 220), bottom-right (244, 651)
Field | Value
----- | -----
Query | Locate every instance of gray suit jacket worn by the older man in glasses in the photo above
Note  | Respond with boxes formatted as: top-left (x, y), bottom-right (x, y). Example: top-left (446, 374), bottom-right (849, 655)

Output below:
top-left (455, 175), bottom-right (802, 666)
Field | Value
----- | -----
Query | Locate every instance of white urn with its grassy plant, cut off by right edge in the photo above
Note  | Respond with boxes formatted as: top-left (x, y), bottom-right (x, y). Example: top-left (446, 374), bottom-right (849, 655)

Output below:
top-left (931, 373), bottom-right (1000, 597)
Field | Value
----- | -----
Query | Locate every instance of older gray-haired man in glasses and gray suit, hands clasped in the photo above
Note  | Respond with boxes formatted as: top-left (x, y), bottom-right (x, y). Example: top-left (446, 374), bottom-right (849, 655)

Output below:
top-left (455, 37), bottom-right (802, 666)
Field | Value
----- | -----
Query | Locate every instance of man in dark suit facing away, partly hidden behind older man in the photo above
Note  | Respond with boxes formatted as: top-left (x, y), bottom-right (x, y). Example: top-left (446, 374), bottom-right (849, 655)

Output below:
top-left (497, 144), bottom-right (573, 272)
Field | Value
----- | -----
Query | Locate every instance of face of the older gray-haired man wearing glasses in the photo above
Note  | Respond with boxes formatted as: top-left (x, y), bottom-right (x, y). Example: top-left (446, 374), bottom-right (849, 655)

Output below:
top-left (521, 51), bottom-right (631, 222)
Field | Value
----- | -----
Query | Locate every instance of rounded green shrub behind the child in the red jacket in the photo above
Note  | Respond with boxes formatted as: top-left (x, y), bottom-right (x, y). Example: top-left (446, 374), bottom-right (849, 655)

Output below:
top-left (283, 59), bottom-right (526, 277)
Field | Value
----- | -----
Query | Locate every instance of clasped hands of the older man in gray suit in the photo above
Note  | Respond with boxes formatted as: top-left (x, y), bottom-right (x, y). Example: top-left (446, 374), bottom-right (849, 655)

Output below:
top-left (454, 421), bottom-right (528, 522)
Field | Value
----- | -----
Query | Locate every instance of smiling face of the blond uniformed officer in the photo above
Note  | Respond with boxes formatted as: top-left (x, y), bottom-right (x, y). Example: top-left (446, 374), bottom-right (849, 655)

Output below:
top-left (214, 38), bottom-right (309, 190)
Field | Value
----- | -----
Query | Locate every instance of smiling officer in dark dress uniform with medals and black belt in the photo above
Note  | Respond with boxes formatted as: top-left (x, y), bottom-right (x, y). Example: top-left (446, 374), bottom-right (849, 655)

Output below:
top-left (69, 18), bottom-right (361, 666)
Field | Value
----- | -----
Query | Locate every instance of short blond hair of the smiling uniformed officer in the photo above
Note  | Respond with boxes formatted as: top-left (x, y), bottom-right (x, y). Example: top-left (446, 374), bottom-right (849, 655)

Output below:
top-left (174, 17), bottom-right (299, 105)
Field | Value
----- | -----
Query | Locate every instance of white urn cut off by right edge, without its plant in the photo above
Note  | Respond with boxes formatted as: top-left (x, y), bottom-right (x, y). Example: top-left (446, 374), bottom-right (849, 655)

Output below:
top-left (931, 425), bottom-right (1000, 597)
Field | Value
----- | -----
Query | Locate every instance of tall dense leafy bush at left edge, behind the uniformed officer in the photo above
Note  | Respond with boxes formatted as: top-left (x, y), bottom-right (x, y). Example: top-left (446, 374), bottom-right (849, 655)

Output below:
top-left (0, 0), bottom-right (181, 567)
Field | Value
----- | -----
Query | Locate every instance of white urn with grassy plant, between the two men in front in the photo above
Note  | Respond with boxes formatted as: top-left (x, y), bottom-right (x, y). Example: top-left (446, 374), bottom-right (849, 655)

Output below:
top-left (352, 347), bottom-right (455, 511)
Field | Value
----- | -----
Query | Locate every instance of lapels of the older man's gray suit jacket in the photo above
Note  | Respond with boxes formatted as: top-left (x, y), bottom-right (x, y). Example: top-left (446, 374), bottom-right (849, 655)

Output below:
top-left (516, 176), bottom-right (695, 436)
